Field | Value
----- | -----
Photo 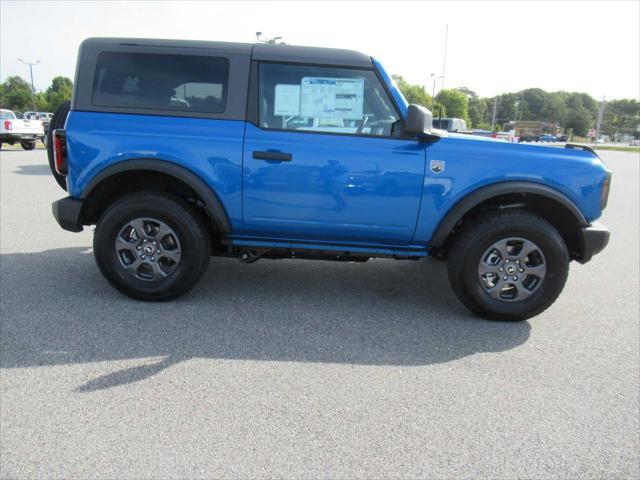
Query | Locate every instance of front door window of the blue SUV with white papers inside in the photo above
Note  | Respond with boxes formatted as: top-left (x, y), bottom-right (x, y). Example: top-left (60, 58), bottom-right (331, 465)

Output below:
top-left (259, 63), bottom-right (400, 136)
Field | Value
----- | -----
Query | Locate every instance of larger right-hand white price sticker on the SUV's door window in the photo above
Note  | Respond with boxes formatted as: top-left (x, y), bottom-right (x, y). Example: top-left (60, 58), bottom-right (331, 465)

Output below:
top-left (300, 77), bottom-right (364, 120)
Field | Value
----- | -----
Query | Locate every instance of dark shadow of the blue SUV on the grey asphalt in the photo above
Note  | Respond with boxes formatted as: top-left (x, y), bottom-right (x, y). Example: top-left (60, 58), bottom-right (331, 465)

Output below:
top-left (0, 248), bottom-right (530, 392)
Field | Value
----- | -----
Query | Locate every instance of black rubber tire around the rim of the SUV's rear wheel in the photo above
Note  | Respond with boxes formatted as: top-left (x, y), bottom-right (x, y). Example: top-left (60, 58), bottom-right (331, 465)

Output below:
top-left (93, 192), bottom-right (211, 301)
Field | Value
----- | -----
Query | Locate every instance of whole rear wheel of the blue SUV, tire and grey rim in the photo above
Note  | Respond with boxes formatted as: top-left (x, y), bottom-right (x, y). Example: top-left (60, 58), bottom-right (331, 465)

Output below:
top-left (93, 192), bottom-right (211, 301)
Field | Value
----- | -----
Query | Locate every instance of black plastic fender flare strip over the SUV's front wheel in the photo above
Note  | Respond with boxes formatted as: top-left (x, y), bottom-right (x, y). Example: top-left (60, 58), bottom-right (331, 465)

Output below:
top-left (429, 181), bottom-right (588, 247)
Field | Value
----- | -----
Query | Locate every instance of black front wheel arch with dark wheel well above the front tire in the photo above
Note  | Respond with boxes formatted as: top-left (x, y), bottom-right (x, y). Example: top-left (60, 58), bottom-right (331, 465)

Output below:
top-left (430, 181), bottom-right (589, 257)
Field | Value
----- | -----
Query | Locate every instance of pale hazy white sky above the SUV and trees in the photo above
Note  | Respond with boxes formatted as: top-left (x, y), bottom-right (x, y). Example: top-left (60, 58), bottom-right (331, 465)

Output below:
top-left (0, 0), bottom-right (640, 99)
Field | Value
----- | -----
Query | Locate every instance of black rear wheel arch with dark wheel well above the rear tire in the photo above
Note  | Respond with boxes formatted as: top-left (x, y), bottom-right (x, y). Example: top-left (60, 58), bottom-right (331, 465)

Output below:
top-left (81, 158), bottom-right (231, 235)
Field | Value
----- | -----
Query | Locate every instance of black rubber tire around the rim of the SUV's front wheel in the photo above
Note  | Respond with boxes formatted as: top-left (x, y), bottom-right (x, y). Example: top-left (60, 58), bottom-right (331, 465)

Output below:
top-left (448, 210), bottom-right (569, 321)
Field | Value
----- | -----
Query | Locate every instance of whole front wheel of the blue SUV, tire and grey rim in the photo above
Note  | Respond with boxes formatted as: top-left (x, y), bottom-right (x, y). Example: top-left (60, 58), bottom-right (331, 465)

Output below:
top-left (448, 210), bottom-right (569, 321)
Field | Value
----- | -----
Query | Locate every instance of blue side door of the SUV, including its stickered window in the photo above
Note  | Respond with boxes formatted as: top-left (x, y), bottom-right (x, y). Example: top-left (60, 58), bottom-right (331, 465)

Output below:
top-left (243, 63), bottom-right (425, 245)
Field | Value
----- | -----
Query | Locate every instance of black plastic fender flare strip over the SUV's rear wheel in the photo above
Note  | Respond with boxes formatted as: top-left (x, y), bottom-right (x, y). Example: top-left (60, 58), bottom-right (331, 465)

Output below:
top-left (80, 158), bottom-right (231, 235)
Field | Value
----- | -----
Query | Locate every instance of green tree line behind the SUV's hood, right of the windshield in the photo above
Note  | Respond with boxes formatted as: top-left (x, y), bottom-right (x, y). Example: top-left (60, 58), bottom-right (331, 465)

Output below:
top-left (393, 75), bottom-right (640, 139)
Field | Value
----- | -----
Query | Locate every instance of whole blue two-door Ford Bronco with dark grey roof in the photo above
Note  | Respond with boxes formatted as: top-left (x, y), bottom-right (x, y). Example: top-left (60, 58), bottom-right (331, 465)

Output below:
top-left (48, 38), bottom-right (611, 320)
